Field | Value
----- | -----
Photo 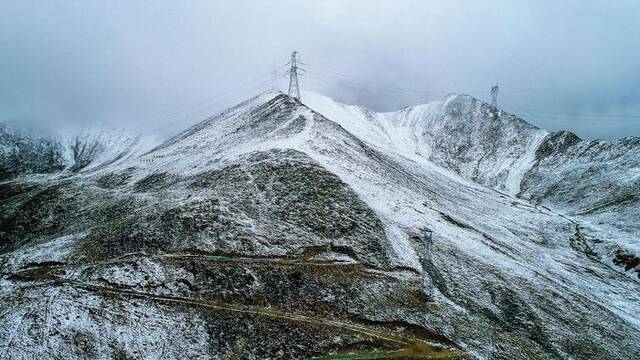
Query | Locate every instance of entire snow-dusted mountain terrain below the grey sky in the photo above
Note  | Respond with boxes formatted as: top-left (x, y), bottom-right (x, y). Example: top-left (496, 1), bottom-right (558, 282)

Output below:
top-left (0, 93), bottom-right (640, 359)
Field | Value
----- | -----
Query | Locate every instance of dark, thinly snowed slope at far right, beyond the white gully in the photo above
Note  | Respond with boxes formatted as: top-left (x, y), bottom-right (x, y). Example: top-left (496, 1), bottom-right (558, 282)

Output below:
top-left (519, 132), bottom-right (640, 258)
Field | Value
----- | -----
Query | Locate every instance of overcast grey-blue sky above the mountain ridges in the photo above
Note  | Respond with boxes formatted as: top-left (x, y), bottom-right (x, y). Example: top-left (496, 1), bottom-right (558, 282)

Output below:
top-left (0, 0), bottom-right (640, 138)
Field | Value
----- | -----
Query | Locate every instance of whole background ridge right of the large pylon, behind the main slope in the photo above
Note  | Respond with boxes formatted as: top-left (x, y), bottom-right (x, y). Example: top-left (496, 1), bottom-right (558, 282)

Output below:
top-left (305, 93), bottom-right (640, 278)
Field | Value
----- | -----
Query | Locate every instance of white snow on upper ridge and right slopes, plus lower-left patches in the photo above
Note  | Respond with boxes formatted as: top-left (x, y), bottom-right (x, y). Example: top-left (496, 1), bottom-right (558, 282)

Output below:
top-left (3, 92), bottom-right (640, 356)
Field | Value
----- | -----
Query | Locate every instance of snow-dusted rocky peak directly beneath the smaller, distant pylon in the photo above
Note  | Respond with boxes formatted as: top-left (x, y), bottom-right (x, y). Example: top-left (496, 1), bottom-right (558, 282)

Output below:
top-left (305, 93), bottom-right (547, 194)
